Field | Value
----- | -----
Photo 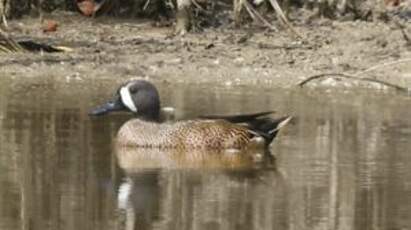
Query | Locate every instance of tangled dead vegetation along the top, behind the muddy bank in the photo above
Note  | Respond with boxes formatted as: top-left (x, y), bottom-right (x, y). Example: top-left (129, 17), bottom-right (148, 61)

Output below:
top-left (0, 0), bottom-right (406, 33)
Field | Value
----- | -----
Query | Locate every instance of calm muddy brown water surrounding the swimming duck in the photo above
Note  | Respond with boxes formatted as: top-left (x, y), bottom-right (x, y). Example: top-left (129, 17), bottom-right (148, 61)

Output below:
top-left (0, 77), bottom-right (411, 230)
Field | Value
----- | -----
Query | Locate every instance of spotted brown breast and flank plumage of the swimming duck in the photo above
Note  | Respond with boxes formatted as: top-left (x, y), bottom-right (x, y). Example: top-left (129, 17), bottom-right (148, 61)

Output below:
top-left (117, 119), bottom-right (256, 149)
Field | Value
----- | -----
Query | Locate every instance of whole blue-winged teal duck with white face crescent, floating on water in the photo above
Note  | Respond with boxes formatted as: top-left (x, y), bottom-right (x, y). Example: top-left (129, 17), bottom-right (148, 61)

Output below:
top-left (90, 80), bottom-right (291, 150)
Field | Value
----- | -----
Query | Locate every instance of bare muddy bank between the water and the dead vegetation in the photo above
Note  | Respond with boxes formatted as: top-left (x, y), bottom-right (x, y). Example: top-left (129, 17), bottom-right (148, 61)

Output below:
top-left (0, 13), bottom-right (411, 88)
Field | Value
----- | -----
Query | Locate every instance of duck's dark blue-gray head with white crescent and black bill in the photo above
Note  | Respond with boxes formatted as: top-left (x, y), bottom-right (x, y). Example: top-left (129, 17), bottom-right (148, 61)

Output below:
top-left (89, 80), bottom-right (160, 121)
